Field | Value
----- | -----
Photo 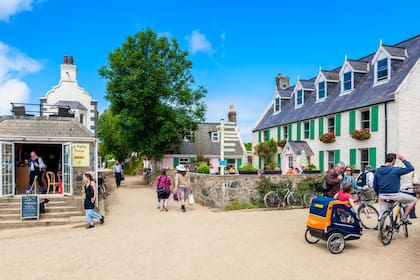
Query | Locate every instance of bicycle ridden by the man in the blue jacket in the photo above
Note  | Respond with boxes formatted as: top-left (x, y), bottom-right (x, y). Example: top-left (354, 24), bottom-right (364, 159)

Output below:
top-left (378, 199), bottom-right (408, 245)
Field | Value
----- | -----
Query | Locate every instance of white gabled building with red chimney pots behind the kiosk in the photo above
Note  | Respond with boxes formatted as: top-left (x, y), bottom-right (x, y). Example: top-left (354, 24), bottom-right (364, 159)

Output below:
top-left (40, 56), bottom-right (98, 133)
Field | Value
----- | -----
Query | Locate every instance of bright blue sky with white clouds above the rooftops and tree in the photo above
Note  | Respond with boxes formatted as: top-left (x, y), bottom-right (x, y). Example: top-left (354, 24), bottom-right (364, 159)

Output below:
top-left (0, 0), bottom-right (420, 142)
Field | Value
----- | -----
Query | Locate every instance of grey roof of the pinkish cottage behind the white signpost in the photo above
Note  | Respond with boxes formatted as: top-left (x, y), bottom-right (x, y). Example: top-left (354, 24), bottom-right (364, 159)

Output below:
top-left (179, 123), bottom-right (245, 158)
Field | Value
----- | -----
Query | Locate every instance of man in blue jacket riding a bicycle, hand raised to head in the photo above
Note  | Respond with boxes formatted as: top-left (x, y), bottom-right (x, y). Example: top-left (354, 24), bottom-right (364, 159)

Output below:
top-left (373, 153), bottom-right (416, 224)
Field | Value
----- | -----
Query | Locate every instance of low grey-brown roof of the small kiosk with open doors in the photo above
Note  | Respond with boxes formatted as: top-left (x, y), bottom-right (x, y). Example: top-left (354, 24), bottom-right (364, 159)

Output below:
top-left (0, 117), bottom-right (95, 139)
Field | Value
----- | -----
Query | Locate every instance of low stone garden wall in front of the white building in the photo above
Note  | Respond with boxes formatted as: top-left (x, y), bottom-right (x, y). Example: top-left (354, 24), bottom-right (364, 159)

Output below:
top-left (170, 173), bottom-right (314, 209)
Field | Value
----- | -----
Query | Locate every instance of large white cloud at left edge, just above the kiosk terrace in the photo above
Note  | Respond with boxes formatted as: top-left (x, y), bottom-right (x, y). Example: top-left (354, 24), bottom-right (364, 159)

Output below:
top-left (0, 41), bottom-right (42, 115)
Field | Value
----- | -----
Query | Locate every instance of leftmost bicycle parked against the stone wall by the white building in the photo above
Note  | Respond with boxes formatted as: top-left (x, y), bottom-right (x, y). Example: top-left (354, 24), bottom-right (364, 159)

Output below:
top-left (264, 187), bottom-right (303, 209)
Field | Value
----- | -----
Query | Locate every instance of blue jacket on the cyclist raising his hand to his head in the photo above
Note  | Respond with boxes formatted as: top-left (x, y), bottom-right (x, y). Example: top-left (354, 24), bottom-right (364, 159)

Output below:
top-left (373, 160), bottom-right (414, 195)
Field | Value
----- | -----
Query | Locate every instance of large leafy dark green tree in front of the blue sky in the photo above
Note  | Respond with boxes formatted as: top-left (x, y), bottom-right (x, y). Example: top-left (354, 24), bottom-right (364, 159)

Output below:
top-left (99, 29), bottom-right (207, 158)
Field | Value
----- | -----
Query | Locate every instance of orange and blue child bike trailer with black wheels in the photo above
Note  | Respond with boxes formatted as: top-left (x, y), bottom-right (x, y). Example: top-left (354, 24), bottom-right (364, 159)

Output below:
top-left (305, 196), bottom-right (362, 254)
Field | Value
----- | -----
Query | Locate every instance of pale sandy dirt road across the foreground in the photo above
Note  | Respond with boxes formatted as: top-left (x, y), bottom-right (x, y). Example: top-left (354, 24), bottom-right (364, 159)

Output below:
top-left (0, 177), bottom-right (420, 280)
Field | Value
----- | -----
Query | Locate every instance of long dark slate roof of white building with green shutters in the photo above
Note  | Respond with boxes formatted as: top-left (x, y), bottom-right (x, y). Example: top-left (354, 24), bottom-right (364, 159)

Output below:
top-left (254, 35), bottom-right (420, 131)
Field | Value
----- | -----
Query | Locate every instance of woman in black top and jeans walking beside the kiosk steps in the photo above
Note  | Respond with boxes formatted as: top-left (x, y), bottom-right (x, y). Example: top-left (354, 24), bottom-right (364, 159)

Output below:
top-left (82, 173), bottom-right (105, 229)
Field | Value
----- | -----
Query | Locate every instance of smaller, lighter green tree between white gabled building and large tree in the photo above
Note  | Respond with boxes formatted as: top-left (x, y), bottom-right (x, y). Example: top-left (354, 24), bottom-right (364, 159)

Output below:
top-left (97, 110), bottom-right (130, 160)
